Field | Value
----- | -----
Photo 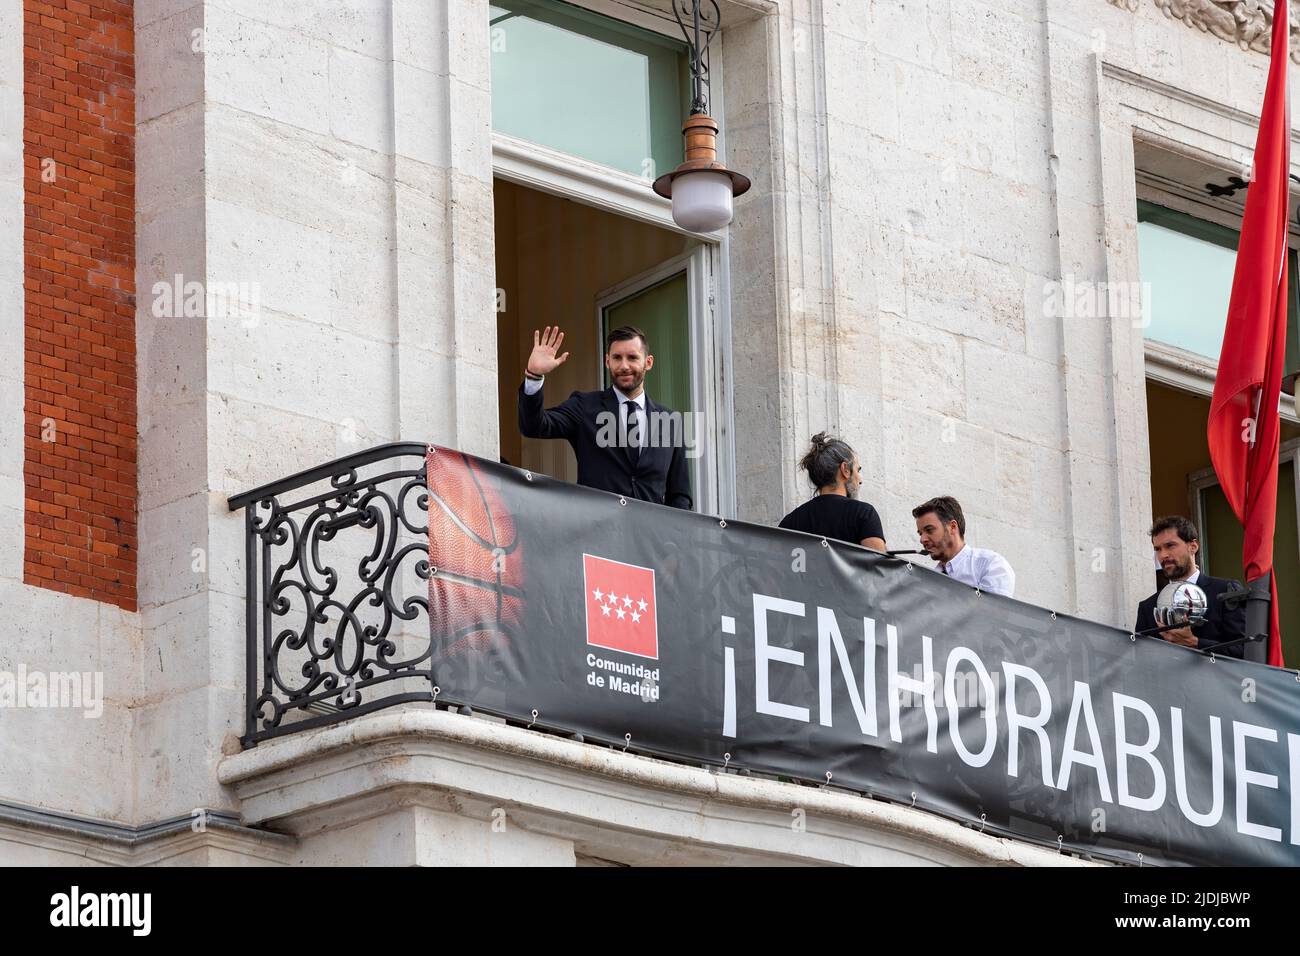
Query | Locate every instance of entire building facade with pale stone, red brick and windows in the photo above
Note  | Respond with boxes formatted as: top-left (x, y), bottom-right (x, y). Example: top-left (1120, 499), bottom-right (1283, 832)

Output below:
top-left (0, 0), bottom-right (1300, 864)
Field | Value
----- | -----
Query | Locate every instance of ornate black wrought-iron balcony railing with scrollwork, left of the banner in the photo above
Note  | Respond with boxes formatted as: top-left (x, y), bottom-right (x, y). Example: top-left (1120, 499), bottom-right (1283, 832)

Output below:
top-left (229, 442), bottom-right (437, 748)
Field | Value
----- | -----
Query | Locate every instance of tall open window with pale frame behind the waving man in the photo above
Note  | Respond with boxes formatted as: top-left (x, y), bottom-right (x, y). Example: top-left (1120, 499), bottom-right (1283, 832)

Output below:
top-left (489, 0), bottom-right (735, 515)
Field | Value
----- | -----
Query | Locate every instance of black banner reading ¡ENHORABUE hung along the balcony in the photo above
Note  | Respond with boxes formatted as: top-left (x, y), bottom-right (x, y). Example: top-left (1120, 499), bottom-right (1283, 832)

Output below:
top-left (428, 446), bottom-right (1300, 865)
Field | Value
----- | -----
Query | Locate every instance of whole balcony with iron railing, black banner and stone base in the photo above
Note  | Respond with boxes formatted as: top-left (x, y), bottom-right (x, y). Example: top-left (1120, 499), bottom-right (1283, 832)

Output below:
top-left (218, 444), bottom-right (1300, 865)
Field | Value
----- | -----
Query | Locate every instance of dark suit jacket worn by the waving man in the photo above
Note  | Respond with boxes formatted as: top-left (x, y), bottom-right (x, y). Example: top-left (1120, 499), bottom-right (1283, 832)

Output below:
top-left (519, 385), bottom-right (692, 511)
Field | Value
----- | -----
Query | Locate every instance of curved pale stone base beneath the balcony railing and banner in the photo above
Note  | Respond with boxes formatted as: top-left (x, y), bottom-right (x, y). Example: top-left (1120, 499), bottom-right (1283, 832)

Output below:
top-left (218, 709), bottom-right (1084, 866)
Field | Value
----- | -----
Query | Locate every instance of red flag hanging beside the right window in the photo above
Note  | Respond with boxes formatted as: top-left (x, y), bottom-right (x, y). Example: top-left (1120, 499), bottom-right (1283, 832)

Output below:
top-left (1208, 3), bottom-right (1291, 667)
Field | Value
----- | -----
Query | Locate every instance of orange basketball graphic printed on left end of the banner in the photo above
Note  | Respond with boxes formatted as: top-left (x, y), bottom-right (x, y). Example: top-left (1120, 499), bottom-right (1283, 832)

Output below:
top-left (426, 445), bottom-right (524, 662)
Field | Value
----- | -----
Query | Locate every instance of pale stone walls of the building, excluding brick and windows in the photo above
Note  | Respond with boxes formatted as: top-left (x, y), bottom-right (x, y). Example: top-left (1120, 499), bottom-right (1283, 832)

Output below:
top-left (0, 0), bottom-right (1268, 862)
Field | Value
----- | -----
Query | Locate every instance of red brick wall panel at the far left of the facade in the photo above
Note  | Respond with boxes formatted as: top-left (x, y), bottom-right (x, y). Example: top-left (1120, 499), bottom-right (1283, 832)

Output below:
top-left (22, 0), bottom-right (137, 610)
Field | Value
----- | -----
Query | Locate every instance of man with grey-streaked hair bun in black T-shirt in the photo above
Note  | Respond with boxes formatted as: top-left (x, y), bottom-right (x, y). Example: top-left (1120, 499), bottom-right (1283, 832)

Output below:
top-left (781, 432), bottom-right (885, 551)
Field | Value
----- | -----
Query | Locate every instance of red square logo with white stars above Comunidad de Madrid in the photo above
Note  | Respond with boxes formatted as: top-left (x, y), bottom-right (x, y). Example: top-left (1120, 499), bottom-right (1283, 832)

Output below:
top-left (582, 554), bottom-right (659, 661)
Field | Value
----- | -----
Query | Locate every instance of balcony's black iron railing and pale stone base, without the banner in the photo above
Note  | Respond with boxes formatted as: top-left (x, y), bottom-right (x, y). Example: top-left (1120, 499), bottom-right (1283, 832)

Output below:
top-left (218, 444), bottom-right (1084, 865)
